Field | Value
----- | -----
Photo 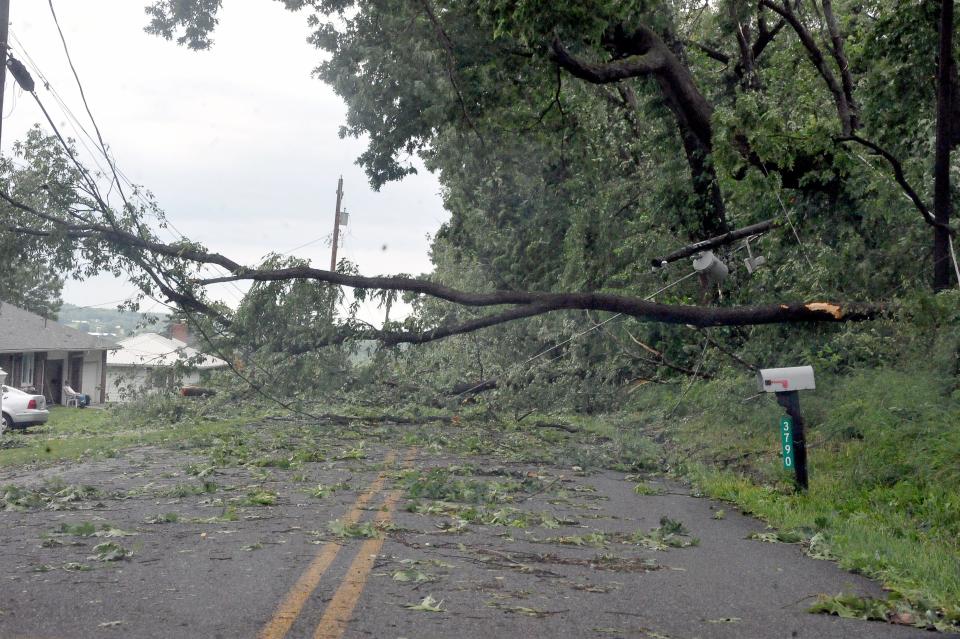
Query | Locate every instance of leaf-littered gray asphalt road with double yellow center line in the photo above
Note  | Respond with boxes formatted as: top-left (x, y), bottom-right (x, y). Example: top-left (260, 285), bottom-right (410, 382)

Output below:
top-left (0, 432), bottom-right (929, 639)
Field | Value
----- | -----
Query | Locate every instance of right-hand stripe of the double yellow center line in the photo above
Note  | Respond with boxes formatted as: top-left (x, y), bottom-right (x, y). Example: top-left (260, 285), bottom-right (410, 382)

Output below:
top-left (313, 449), bottom-right (417, 639)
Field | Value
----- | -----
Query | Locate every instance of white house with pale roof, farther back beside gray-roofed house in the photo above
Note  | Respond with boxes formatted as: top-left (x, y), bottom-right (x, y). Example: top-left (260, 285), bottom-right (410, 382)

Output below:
top-left (106, 333), bottom-right (227, 402)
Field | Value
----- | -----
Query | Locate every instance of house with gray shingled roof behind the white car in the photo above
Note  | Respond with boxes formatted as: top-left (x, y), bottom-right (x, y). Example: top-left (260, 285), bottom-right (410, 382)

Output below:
top-left (0, 302), bottom-right (116, 404)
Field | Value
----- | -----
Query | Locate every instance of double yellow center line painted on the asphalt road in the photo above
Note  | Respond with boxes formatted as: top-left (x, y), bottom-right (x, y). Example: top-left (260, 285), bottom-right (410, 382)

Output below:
top-left (257, 449), bottom-right (416, 639)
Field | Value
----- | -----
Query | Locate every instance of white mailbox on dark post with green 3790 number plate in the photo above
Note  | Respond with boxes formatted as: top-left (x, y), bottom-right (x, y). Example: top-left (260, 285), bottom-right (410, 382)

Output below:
top-left (757, 366), bottom-right (817, 490)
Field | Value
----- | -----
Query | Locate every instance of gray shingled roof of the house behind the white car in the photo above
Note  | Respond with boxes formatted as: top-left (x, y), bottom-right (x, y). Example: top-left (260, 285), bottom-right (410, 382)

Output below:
top-left (0, 302), bottom-right (115, 353)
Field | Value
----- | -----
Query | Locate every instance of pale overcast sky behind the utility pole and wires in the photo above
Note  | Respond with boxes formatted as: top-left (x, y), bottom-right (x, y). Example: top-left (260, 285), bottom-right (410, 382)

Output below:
top-left (2, 0), bottom-right (447, 316)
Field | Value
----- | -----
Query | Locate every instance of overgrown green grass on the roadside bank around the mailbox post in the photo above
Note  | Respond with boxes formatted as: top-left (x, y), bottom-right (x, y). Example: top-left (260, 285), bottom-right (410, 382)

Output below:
top-left (636, 369), bottom-right (960, 622)
